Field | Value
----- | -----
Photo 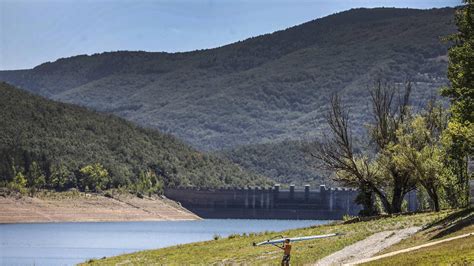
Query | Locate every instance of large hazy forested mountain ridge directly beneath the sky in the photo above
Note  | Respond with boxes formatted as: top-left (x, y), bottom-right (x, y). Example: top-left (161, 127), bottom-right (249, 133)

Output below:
top-left (0, 8), bottom-right (454, 150)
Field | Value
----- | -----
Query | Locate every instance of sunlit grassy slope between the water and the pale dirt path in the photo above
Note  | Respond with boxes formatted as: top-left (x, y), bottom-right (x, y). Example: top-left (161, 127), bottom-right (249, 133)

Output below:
top-left (82, 211), bottom-right (462, 265)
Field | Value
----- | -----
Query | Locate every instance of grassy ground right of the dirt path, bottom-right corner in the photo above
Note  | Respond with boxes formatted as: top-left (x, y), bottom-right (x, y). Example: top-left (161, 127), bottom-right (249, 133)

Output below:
top-left (364, 208), bottom-right (474, 265)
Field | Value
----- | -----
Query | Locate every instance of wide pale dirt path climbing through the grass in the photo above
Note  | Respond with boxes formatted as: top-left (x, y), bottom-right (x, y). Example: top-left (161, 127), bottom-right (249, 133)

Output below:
top-left (315, 227), bottom-right (421, 265)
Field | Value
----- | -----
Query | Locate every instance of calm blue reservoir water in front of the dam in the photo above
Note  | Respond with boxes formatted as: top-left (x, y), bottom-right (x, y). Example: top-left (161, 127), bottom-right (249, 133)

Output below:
top-left (0, 219), bottom-right (329, 265)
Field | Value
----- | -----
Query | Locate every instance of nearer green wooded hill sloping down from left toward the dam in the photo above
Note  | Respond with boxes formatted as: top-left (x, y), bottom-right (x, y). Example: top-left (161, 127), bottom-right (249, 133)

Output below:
top-left (0, 83), bottom-right (270, 191)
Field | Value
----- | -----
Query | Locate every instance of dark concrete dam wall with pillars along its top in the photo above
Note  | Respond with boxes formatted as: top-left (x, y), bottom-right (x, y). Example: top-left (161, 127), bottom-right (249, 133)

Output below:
top-left (165, 185), bottom-right (362, 220)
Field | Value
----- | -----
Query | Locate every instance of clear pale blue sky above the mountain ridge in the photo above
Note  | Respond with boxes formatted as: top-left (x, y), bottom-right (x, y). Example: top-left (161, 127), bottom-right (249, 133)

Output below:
top-left (0, 0), bottom-right (461, 70)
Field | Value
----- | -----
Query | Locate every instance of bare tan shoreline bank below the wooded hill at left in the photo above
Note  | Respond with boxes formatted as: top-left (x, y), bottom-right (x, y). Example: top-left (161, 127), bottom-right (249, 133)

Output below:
top-left (0, 192), bottom-right (201, 224)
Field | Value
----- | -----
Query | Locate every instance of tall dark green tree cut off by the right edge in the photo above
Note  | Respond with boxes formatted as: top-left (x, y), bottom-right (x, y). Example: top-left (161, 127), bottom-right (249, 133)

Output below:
top-left (442, 0), bottom-right (474, 205)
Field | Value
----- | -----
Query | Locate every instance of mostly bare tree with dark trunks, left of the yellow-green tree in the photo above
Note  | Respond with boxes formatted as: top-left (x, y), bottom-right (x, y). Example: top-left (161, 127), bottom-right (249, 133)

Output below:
top-left (311, 81), bottom-right (416, 213)
